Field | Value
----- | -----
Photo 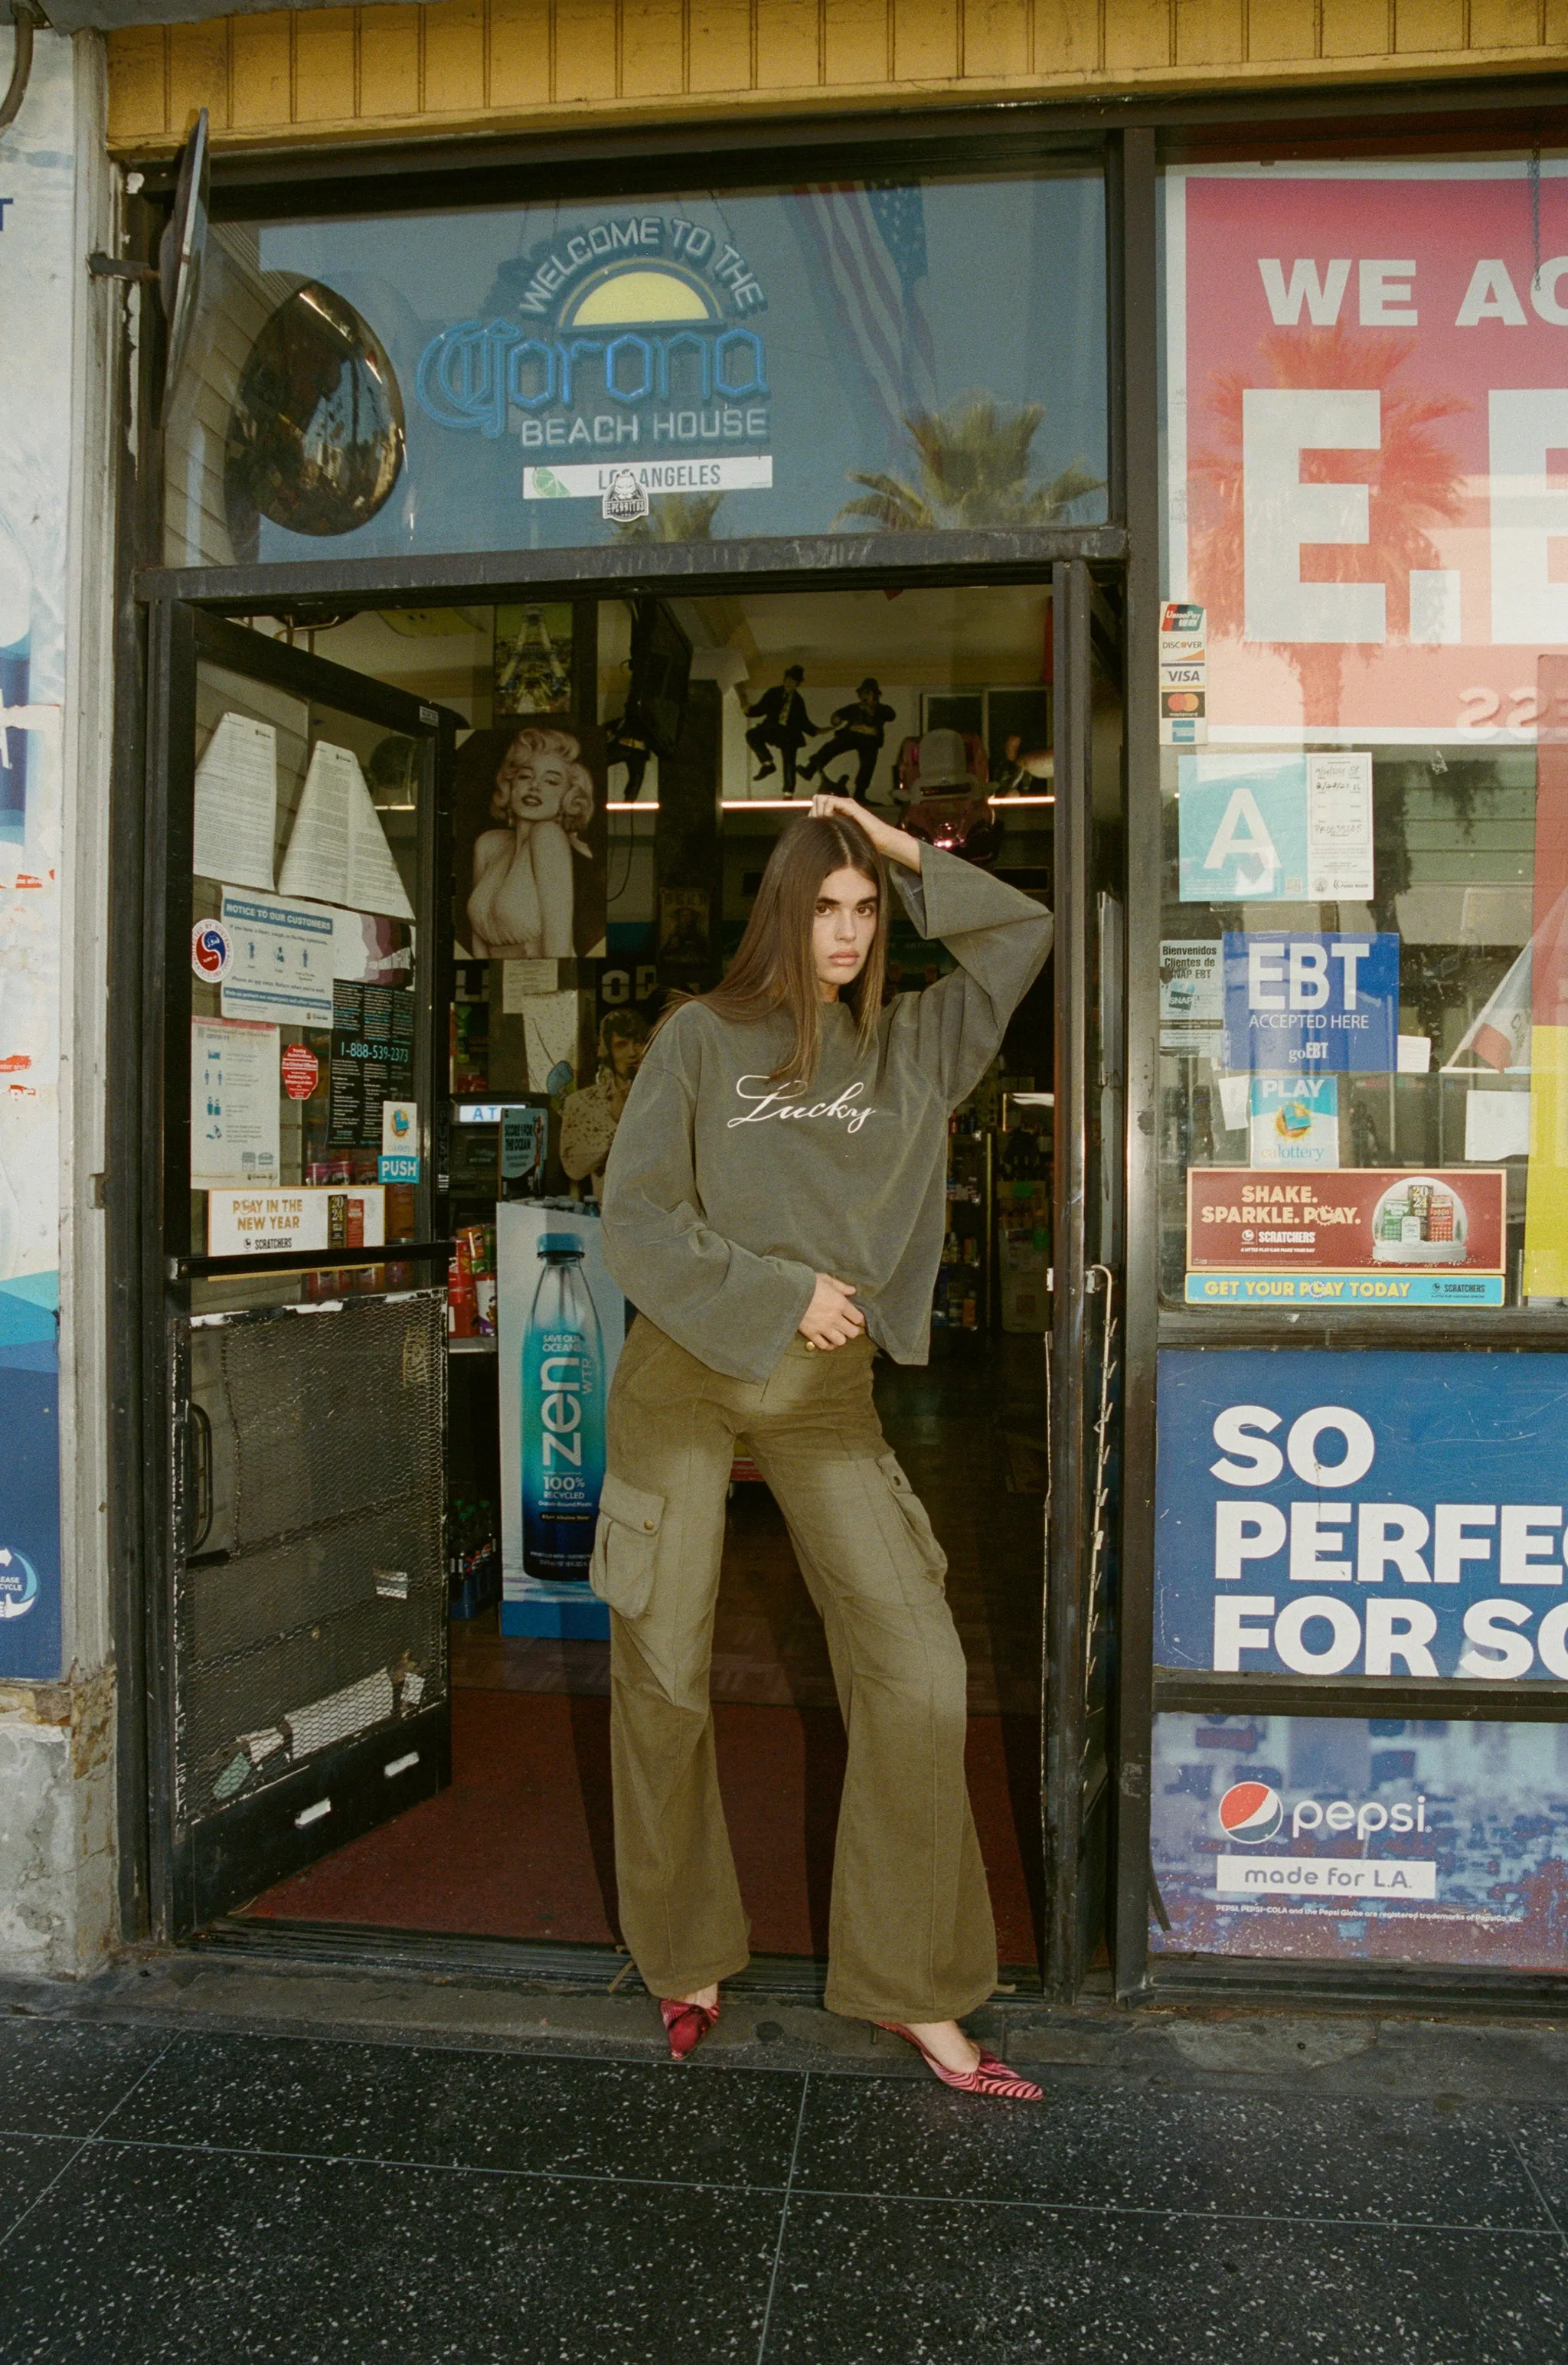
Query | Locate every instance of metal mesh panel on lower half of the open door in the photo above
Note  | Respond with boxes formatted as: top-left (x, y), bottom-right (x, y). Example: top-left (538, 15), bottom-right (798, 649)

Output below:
top-left (175, 1289), bottom-right (447, 1824)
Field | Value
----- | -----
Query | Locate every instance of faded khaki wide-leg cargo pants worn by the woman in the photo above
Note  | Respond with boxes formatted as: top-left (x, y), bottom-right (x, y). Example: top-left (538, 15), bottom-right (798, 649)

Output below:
top-left (591, 1318), bottom-right (995, 2020)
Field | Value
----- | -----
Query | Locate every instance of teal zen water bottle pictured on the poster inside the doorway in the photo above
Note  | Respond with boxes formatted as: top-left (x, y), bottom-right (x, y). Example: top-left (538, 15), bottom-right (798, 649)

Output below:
top-left (523, 1232), bottom-right (606, 1579)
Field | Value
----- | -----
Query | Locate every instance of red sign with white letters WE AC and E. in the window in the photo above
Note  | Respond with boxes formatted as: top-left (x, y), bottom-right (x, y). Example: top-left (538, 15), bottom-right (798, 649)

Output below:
top-left (1166, 158), bottom-right (1568, 745)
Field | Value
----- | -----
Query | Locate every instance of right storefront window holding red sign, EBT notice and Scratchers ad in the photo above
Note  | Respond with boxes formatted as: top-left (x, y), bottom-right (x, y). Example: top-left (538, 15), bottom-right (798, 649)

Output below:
top-left (1159, 158), bottom-right (1568, 1312)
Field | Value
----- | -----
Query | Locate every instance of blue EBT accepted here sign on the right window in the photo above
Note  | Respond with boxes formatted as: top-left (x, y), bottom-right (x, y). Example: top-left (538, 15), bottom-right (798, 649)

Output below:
top-left (1223, 934), bottom-right (1400, 1076)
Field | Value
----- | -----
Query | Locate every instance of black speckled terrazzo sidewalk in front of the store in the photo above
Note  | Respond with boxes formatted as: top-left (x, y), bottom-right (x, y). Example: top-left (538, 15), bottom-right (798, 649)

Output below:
top-left (0, 1982), bottom-right (1568, 2365)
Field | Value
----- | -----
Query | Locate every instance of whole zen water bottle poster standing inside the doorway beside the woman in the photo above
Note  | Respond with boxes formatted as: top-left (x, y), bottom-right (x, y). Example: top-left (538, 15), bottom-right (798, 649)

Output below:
top-left (497, 1201), bottom-right (627, 1637)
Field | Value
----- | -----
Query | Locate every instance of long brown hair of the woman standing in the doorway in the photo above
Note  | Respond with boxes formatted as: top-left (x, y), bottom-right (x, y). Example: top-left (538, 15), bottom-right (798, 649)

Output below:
top-left (697, 814), bottom-right (887, 1083)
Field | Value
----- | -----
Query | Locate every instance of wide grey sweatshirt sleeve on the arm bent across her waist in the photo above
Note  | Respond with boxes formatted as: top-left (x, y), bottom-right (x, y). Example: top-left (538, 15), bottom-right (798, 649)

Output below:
top-left (603, 1014), bottom-right (816, 1381)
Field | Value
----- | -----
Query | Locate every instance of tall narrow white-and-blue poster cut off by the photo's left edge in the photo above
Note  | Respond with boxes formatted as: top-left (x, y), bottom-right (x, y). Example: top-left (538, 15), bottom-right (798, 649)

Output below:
top-left (0, 28), bottom-right (74, 1677)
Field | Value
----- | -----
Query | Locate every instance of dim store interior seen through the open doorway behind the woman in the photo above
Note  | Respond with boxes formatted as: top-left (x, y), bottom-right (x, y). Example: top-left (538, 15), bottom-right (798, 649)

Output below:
top-left (194, 586), bottom-right (1055, 1968)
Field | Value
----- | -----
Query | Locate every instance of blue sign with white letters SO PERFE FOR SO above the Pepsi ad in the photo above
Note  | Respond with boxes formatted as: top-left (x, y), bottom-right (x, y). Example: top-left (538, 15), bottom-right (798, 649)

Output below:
top-left (1154, 1348), bottom-right (1568, 1684)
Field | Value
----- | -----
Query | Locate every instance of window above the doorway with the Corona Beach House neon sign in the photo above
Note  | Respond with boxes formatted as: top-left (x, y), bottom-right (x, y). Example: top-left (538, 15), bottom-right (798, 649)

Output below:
top-left (165, 161), bottom-right (1107, 565)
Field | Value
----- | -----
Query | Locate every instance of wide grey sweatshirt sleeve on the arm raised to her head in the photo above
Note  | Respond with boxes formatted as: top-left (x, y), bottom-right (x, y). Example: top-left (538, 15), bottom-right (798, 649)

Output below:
top-left (894, 847), bottom-right (1055, 1109)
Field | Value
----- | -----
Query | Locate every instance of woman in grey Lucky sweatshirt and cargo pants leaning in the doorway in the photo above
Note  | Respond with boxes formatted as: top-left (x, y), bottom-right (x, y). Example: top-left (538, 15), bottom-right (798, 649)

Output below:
top-left (593, 797), bottom-right (1050, 2100)
